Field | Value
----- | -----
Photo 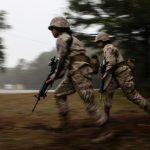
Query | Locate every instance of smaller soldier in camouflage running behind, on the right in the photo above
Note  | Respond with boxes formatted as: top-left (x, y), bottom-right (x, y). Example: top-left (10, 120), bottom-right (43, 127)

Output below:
top-left (95, 32), bottom-right (150, 124)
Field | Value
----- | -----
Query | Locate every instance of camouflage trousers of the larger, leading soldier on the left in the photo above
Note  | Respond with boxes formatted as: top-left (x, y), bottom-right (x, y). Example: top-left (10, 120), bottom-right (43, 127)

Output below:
top-left (55, 71), bottom-right (101, 123)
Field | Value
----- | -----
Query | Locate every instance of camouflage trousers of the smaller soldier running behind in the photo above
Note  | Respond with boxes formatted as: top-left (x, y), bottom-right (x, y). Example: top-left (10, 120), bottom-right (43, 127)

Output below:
top-left (104, 66), bottom-right (147, 109)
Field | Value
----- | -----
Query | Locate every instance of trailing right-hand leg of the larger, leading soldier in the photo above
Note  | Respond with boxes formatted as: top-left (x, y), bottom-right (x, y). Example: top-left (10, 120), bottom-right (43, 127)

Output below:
top-left (72, 74), bottom-right (101, 126)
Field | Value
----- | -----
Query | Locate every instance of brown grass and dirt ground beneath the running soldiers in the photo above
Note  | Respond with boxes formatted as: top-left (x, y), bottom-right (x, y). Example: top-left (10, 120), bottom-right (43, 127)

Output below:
top-left (0, 93), bottom-right (150, 150)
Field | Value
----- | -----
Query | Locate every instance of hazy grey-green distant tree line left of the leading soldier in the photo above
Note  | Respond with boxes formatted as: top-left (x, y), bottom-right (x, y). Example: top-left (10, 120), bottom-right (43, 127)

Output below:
top-left (0, 50), bottom-right (58, 90)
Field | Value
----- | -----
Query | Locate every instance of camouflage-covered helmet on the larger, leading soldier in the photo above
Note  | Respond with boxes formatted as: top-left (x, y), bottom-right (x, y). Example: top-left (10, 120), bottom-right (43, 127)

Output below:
top-left (48, 17), bottom-right (70, 30)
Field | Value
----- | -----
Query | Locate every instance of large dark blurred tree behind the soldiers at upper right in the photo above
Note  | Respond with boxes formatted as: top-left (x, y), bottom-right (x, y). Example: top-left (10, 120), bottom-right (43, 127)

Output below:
top-left (65, 0), bottom-right (150, 91)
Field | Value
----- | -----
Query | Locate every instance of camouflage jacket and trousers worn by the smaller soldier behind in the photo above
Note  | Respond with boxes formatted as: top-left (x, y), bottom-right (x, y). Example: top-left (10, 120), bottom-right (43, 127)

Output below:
top-left (103, 44), bottom-right (146, 108)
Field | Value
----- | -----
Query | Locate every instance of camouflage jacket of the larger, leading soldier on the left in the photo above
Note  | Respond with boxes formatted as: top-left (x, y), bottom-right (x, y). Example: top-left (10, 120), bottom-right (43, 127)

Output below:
top-left (56, 33), bottom-right (93, 77)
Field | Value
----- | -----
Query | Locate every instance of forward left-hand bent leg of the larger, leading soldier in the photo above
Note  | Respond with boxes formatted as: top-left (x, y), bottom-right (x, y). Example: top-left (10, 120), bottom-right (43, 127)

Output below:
top-left (55, 77), bottom-right (75, 128)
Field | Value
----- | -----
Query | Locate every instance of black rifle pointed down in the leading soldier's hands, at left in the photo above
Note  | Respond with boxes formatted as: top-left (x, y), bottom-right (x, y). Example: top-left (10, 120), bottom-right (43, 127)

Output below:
top-left (32, 56), bottom-right (59, 112)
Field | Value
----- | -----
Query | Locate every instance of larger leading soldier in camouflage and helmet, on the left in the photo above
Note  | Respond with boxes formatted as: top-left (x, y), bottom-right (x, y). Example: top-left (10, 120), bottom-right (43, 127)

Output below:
top-left (47, 17), bottom-right (101, 128)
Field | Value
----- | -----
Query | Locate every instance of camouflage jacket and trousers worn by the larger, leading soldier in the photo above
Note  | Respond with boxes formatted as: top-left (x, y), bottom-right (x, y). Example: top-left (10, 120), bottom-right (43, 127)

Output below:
top-left (48, 16), bottom-right (101, 127)
